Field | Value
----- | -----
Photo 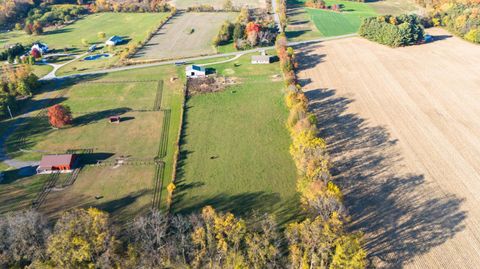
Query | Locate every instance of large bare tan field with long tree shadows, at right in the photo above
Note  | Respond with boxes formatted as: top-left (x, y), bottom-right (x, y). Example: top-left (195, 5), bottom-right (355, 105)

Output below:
top-left (299, 29), bottom-right (480, 268)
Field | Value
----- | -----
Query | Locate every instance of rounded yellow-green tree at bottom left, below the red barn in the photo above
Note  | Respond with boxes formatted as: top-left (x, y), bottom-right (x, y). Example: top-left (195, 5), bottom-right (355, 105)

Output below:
top-left (47, 208), bottom-right (117, 269)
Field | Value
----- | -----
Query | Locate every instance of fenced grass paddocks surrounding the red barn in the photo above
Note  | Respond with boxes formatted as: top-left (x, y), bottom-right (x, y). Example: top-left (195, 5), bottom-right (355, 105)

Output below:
top-left (0, 66), bottom-right (183, 220)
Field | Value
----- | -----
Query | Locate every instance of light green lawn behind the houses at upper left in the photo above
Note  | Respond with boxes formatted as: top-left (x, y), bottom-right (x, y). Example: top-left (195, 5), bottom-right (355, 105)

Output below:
top-left (0, 12), bottom-right (166, 51)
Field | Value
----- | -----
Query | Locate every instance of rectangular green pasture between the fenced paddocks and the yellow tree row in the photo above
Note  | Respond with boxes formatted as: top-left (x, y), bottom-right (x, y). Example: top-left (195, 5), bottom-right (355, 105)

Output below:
top-left (174, 55), bottom-right (297, 221)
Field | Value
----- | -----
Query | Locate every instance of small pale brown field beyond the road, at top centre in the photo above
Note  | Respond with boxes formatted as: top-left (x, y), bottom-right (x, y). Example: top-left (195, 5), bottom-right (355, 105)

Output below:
top-left (134, 12), bottom-right (236, 59)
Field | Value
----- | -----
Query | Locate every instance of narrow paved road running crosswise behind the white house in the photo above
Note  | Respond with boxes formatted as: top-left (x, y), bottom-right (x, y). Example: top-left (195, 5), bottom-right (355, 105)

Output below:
top-left (41, 34), bottom-right (357, 80)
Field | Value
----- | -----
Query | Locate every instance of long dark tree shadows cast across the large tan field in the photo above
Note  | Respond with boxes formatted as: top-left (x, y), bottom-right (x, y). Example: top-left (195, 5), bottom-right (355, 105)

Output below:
top-left (302, 88), bottom-right (466, 268)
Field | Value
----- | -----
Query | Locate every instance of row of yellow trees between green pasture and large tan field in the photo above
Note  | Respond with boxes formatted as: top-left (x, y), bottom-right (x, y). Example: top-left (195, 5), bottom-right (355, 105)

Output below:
top-left (275, 33), bottom-right (367, 268)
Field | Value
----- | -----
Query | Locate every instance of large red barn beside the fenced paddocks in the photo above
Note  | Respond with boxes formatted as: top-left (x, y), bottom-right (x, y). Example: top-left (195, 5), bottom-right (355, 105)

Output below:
top-left (37, 154), bottom-right (77, 174)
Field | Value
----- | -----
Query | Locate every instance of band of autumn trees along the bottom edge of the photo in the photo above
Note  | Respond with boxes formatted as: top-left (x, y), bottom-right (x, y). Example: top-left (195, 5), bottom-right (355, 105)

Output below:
top-left (0, 206), bottom-right (364, 269)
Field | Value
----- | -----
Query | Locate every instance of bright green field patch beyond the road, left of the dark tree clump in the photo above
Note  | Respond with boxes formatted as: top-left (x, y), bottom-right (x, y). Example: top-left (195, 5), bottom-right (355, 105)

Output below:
top-left (307, 1), bottom-right (377, 37)
